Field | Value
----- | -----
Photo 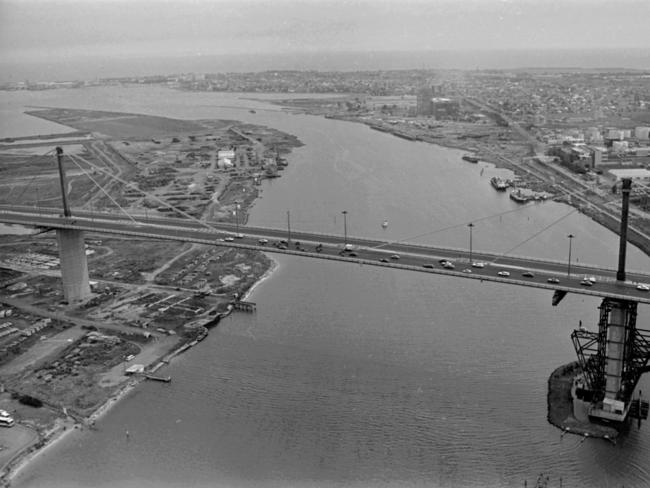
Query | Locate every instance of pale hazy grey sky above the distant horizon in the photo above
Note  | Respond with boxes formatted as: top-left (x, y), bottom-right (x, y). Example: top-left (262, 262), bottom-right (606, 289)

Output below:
top-left (0, 0), bottom-right (650, 77)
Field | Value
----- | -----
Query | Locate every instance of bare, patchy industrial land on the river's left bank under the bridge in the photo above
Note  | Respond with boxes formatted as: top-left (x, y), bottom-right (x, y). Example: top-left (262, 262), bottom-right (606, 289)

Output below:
top-left (0, 109), bottom-right (301, 476)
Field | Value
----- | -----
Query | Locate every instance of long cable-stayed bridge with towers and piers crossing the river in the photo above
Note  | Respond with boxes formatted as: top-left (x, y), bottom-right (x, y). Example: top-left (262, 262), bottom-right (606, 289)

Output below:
top-left (0, 148), bottom-right (650, 425)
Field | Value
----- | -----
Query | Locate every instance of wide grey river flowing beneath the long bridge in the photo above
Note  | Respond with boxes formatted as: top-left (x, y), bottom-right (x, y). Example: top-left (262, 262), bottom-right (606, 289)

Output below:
top-left (0, 87), bottom-right (650, 488)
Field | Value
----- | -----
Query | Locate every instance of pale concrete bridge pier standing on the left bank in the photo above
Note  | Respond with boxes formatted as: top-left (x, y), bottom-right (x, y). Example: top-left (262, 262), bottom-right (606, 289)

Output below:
top-left (56, 229), bottom-right (90, 303)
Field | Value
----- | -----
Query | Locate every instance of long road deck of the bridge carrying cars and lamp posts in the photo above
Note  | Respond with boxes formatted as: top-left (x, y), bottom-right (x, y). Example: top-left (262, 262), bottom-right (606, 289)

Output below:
top-left (0, 208), bottom-right (650, 303)
